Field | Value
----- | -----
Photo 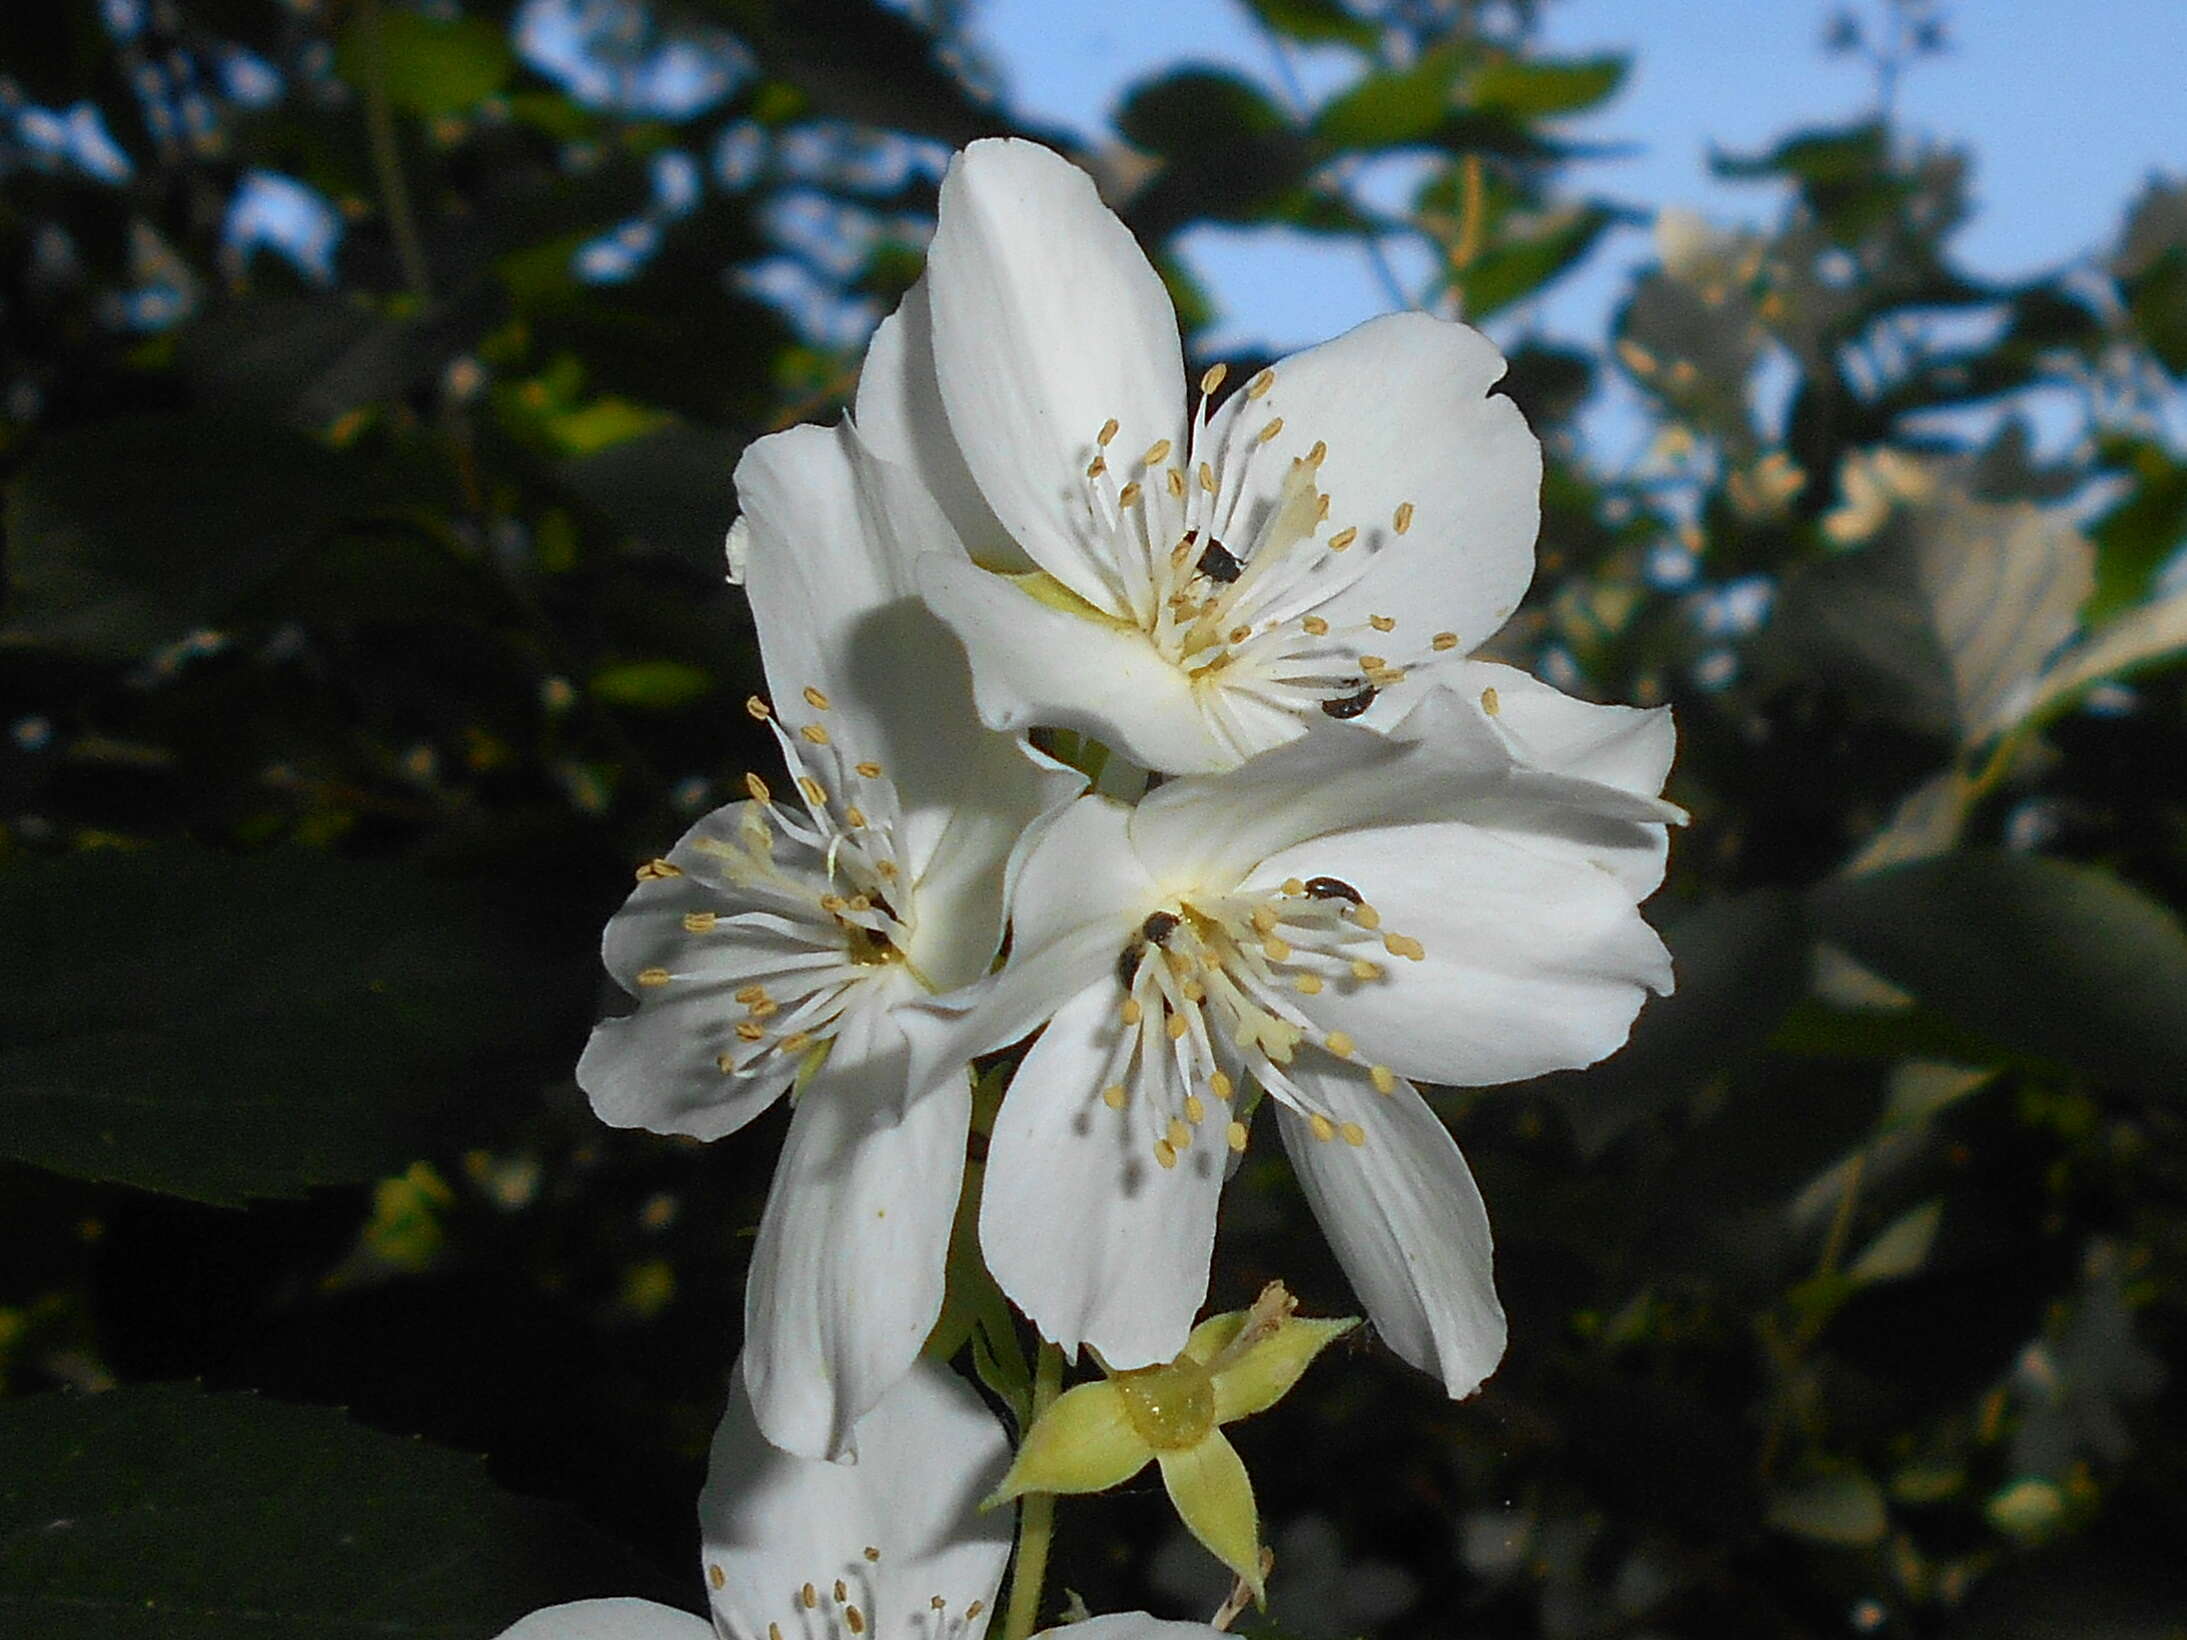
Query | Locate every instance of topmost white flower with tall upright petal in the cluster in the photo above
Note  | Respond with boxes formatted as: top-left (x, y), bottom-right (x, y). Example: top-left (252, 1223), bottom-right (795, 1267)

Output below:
top-left (857, 140), bottom-right (1542, 774)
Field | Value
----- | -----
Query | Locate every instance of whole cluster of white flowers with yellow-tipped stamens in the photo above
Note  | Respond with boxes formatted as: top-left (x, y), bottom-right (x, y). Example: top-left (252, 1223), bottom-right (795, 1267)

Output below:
top-left (512, 142), bottom-right (1682, 1640)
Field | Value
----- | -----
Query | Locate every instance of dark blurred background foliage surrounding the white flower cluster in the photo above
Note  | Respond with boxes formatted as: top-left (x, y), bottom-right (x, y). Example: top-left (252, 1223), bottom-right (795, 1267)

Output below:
top-left (0, 0), bottom-right (2187, 1640)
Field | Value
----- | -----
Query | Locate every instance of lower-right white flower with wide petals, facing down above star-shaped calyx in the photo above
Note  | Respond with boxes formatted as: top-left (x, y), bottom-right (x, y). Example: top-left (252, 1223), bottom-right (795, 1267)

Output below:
top-left (940, 686), bottom-right (1682, 1395)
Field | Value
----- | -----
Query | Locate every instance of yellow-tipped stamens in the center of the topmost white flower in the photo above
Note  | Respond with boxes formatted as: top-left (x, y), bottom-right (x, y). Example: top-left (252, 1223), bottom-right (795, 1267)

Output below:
top-left (1067, 365), bottom-right (1459, 757)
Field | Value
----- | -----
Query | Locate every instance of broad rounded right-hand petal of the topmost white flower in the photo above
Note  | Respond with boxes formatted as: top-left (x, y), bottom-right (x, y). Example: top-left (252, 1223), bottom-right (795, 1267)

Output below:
top-left (1212, 313), bottom-right (1542, 654)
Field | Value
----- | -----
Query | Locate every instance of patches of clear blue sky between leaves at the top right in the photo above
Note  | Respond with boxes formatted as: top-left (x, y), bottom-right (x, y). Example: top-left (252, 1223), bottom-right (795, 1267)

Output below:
top-left (973, 0), bottom-right (2187, 358)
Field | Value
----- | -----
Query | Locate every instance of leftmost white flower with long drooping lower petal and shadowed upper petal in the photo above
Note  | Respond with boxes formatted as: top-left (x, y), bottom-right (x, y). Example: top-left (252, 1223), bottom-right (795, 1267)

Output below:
top-left (577, 426), bottom-right (1076, 1456)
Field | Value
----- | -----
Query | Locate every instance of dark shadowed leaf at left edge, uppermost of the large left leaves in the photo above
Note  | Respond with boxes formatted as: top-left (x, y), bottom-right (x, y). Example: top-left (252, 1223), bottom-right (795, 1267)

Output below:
top-left (0, 415), bottom-right (374, 660)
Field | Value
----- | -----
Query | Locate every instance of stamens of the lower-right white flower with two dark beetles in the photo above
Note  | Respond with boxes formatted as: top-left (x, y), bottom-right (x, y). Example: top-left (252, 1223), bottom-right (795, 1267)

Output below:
top-left (1102, 877), bottom-right (1426, 1168)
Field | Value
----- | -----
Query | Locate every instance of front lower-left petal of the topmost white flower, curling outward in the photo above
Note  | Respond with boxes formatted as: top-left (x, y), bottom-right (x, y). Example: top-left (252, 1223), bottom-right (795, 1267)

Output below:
top-left (919, 558), bottom-right (1238, 774)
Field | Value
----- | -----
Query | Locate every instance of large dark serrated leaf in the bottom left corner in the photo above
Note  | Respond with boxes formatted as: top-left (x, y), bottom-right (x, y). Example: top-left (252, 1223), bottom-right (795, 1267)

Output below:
top-left (0, 1384), bottom-right (680, 1640)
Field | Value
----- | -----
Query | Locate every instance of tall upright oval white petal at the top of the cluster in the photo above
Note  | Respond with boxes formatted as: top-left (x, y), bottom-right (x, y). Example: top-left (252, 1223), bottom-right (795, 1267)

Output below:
top-left (925, 140), bottom-right (1185, 608)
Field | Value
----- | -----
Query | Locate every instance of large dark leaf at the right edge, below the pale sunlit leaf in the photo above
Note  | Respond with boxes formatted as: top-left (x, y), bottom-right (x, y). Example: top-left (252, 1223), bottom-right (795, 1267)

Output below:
top-left (1811, 853), bottom-right (2187, 1098)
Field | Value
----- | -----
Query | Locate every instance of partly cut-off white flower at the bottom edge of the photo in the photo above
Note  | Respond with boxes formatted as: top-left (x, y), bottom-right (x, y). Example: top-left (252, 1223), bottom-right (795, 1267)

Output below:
top-left (501, 1362), bottom-right (1214, 1640)
